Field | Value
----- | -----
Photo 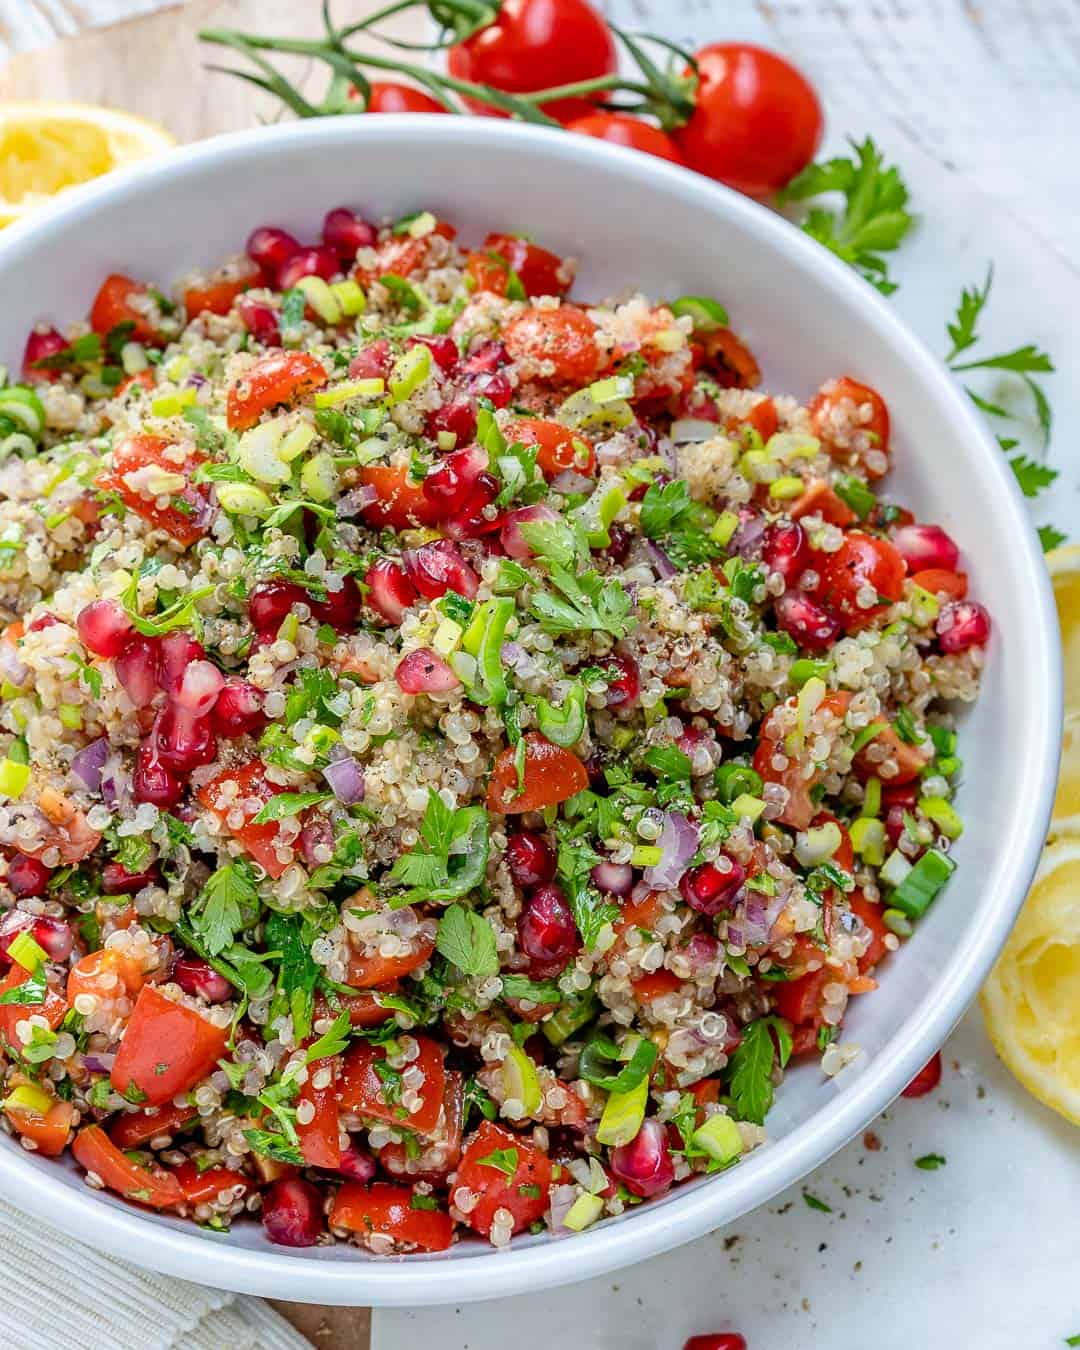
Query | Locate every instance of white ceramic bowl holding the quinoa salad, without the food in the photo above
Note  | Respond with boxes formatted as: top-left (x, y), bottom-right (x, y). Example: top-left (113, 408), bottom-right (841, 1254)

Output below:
top-left (0, 116), bottom-right (1061, 1304)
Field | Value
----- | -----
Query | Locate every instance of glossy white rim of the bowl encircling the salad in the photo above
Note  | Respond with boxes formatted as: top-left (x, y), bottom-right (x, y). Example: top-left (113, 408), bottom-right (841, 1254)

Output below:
top-left (0, 113), bottom-right (1062, 1307)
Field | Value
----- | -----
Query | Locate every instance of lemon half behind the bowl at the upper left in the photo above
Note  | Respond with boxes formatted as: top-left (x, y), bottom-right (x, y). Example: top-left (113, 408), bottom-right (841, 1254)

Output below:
top-left (0, 101), bottom-right (176, 225)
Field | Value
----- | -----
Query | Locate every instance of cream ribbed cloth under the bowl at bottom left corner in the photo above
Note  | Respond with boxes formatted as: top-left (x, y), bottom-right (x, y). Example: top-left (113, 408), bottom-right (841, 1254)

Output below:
top-left (0, 1200), bottom-right (311, 1350)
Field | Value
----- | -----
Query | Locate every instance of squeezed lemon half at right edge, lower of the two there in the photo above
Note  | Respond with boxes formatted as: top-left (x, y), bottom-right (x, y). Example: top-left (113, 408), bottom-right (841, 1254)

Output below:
top-left (980, 838), bottom-right (1080, 1125)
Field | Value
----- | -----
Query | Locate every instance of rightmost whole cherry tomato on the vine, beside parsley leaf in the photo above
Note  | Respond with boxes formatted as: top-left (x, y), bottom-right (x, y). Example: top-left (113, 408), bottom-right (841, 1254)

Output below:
top-left (675, 42), bottom-right (824, 197)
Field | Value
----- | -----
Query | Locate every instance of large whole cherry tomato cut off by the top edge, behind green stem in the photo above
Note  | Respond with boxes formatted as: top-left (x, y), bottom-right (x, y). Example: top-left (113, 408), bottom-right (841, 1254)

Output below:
top-left (450, 0), bottom-right (618, 122)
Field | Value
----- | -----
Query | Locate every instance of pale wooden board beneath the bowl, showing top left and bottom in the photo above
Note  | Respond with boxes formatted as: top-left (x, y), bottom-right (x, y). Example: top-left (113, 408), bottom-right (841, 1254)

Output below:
top-left (0, 0), bottom-right (423, 1350)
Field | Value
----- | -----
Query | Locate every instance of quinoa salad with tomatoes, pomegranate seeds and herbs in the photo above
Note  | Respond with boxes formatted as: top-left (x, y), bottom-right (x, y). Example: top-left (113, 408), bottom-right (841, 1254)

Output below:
top-left (0, 209), bottom-right (990, 1254)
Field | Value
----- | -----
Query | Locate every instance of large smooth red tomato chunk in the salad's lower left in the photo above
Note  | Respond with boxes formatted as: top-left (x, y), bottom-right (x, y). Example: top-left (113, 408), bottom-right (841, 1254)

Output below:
top-left (109, 984), bottom-right (228, 1106)
